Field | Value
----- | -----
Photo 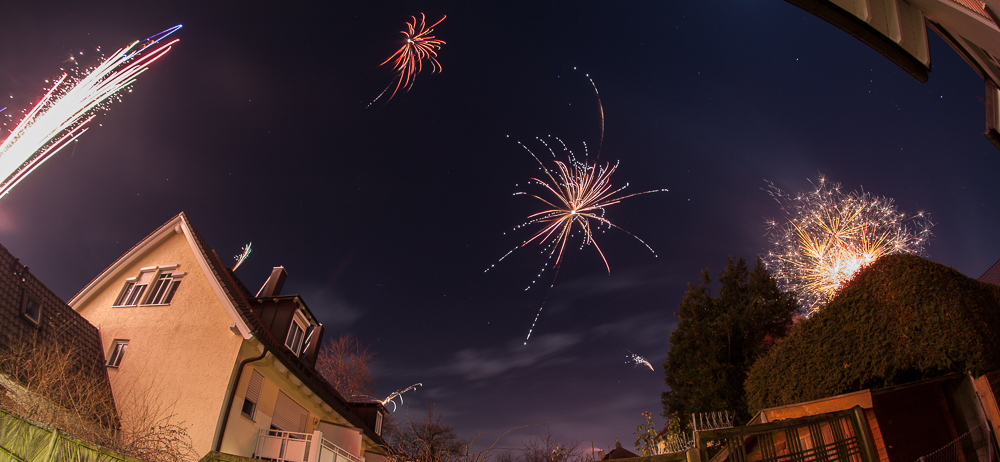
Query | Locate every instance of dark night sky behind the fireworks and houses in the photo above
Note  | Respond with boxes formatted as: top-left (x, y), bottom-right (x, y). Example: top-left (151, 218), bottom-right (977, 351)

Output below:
top-left (0, 0), bottom-right (1000, 449)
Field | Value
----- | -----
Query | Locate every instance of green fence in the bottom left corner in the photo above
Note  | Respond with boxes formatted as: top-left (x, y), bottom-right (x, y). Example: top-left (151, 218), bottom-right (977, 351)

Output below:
top-left (0, 409), bottom-right (142, 462)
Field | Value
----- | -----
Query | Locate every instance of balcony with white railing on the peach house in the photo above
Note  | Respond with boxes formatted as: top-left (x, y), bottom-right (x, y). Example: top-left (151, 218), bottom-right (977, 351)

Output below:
top-left (254, 430), bottom-right (364, 462)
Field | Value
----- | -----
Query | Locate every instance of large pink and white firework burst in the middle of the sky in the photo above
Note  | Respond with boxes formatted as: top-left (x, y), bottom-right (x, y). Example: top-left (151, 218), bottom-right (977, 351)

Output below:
top-left (486, 137), bottom-right (667, 344)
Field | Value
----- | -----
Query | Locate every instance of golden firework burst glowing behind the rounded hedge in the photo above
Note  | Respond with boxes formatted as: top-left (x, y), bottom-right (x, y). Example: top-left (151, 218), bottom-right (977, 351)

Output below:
top-left (764, 175), bottom-right (934, 316)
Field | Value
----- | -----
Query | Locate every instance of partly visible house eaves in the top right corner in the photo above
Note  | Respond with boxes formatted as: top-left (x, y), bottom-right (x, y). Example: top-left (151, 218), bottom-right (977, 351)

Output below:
top-left (786, 0), bottom-right (1000, 148)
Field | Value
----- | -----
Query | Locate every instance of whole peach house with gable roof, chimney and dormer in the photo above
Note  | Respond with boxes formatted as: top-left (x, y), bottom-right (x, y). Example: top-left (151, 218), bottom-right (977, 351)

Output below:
top-left (70, 213), bottom-right (385, 462)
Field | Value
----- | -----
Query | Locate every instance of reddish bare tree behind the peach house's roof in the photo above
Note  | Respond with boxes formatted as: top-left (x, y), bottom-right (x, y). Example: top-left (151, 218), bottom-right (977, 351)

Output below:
top-left (316, 334), bottom-right (376, 401)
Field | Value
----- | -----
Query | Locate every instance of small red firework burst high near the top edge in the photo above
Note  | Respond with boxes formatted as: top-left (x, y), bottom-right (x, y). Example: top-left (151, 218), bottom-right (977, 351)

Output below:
top-left (368, 13), bottom-right (448, 106)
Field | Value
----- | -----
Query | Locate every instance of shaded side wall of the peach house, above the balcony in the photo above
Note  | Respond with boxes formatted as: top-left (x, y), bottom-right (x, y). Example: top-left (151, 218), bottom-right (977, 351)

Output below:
top-left (221, 342), bottom-right (363, 457)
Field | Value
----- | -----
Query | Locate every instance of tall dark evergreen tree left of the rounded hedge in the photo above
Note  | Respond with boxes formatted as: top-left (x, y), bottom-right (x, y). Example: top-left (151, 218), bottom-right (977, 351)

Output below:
top-left (662, 256), bottom-right (798, 429)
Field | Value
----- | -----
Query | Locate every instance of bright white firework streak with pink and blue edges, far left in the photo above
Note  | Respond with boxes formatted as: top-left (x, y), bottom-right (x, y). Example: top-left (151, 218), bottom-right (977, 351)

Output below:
top-left (0, 25), bottom-right (181, 197)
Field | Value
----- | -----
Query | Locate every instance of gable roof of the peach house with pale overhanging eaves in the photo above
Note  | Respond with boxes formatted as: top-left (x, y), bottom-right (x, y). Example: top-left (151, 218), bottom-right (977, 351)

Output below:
top-left (69, 212), bottom-right (386, 446)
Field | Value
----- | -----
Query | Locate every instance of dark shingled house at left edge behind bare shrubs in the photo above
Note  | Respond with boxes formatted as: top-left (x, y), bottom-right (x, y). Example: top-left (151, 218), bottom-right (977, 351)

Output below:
top-left (0, 242), bottom-right (118, 436)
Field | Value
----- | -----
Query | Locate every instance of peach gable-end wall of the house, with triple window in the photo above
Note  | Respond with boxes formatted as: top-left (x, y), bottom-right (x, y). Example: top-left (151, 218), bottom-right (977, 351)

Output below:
top-left (76, 228), bottom-right (243, 455)
